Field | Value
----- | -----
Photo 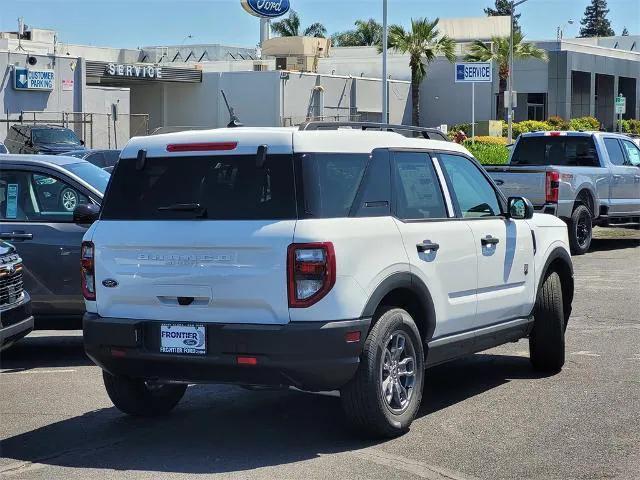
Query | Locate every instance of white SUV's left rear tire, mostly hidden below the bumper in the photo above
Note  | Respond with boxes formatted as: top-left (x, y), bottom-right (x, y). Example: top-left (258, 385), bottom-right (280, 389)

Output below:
top-left (102, 371), bottom-right (187, 417)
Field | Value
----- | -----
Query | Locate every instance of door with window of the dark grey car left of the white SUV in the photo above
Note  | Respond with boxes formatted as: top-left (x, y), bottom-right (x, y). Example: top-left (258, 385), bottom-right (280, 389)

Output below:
top-left (0, 166), bottom-right (97, 316)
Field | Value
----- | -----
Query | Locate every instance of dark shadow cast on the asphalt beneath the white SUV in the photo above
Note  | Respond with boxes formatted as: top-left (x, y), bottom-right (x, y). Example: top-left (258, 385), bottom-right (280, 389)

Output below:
top-left (0, 354), bottom-right (536, 474)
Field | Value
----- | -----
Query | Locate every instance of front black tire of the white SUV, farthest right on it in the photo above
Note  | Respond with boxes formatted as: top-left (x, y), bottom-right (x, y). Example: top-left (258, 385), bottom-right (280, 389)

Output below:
top-left (529, 272), bottom-right (565, 373)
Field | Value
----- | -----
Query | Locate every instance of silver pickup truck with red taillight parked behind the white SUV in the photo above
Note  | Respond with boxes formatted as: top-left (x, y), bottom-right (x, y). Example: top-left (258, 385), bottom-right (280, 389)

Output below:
top-left (485, 131), bottom-right (640, 255)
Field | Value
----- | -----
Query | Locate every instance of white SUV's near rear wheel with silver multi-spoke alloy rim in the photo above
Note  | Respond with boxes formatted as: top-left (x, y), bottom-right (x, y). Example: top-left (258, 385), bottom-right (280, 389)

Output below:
top-left (340, 308), bottom-right (424, 437)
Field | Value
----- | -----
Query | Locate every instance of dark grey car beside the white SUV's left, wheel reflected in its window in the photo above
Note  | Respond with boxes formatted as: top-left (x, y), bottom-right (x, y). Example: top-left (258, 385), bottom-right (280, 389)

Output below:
top-left (0, 155), bottom-right (110, 328)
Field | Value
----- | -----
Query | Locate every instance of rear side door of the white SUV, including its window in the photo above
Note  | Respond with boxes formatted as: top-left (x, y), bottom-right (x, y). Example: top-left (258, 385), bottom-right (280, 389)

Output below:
top-left (391, 151), bottom-right (477, 339)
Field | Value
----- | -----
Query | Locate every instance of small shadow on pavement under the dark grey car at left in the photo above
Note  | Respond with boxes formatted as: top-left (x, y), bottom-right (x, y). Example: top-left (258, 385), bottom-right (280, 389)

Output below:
top-left (0, 333), bottom-right (93, 371)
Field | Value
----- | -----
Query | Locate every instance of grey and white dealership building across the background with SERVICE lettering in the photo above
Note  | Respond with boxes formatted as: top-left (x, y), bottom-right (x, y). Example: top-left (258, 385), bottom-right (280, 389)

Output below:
top-left (0, 17), bottom-right (640, 147)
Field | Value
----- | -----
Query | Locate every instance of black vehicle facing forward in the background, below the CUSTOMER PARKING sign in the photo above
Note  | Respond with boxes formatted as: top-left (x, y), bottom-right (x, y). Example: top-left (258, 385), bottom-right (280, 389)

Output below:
top-left (4, 124), bottom-right (84, 155)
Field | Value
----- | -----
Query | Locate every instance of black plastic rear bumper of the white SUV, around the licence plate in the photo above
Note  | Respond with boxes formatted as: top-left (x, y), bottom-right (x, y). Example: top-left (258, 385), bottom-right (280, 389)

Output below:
top-left (83, 313), bottom-right (371, 390)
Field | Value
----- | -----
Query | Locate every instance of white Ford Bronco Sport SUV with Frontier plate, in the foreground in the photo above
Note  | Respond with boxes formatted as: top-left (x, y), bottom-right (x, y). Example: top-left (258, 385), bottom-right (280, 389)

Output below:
top-left (82, 125), bottom-right (573, 436)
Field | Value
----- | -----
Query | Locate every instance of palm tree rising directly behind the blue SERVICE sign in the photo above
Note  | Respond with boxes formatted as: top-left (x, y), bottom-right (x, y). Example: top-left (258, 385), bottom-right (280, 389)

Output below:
top-left (465, 30), bottom-right (549, 116)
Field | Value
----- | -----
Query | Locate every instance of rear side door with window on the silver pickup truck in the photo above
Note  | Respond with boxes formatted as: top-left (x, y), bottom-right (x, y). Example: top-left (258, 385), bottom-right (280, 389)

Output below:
top-left (603, 137), bottom-right (638, 215)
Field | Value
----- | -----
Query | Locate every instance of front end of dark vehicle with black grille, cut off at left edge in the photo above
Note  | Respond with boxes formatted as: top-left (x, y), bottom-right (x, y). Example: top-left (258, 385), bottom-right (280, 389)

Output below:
top-left (0, 240), bottom-right (33, 352)
